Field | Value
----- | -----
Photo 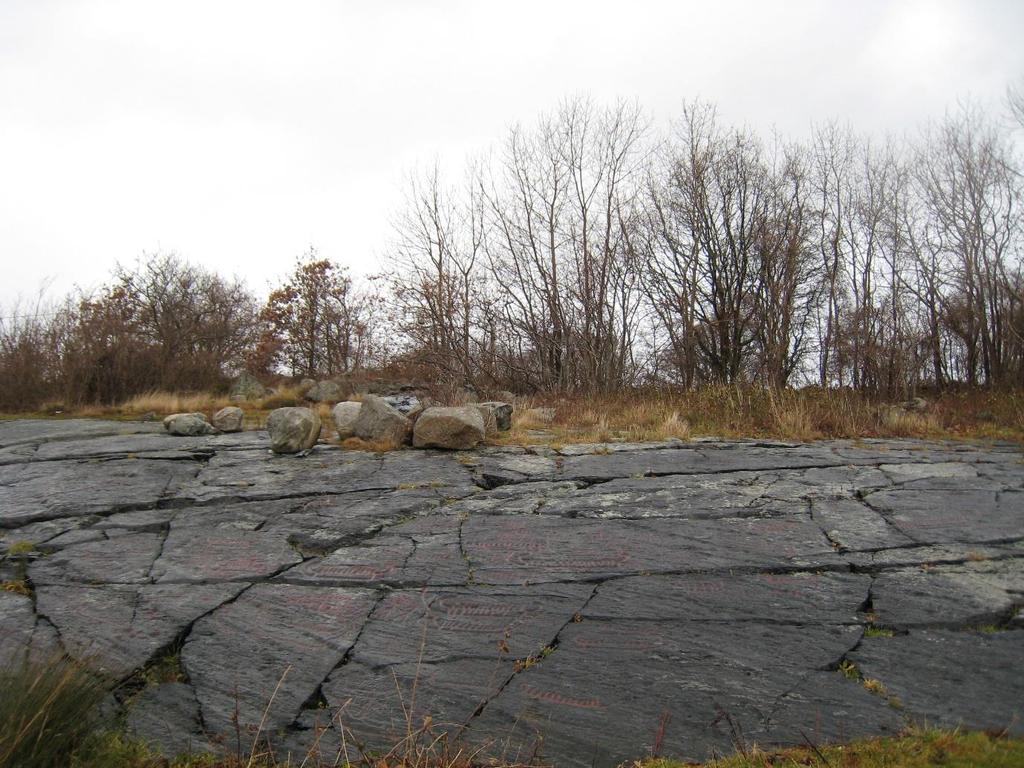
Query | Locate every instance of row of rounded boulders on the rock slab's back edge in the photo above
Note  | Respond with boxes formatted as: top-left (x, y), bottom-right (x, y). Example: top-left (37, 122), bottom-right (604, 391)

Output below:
top-left (164, 382), bottom-right (512, 454)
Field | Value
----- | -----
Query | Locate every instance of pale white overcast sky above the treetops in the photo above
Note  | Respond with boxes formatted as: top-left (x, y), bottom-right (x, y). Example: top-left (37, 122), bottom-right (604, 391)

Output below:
top-left (0, 0), bottom-right (1024, 306)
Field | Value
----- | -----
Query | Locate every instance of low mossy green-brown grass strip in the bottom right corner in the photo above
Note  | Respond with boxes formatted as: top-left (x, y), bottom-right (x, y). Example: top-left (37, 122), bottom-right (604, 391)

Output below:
top-left (636, 730), bottom-right (1024, 768)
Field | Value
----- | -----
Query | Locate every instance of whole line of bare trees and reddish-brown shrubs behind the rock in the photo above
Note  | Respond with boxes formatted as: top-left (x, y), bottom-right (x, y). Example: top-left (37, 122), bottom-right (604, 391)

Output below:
top-left (0, 91), bottom-right (1024, 410)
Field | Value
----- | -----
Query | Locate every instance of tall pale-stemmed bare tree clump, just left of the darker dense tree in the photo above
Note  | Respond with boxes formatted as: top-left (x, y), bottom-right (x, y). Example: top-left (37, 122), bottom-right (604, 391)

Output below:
top-left (484, 99), bottom-right (645, 389)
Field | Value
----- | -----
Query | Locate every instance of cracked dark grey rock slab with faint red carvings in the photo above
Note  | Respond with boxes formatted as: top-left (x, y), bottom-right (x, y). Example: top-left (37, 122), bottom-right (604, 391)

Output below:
top-left (0, 420), bottom-right (1024, 767)
